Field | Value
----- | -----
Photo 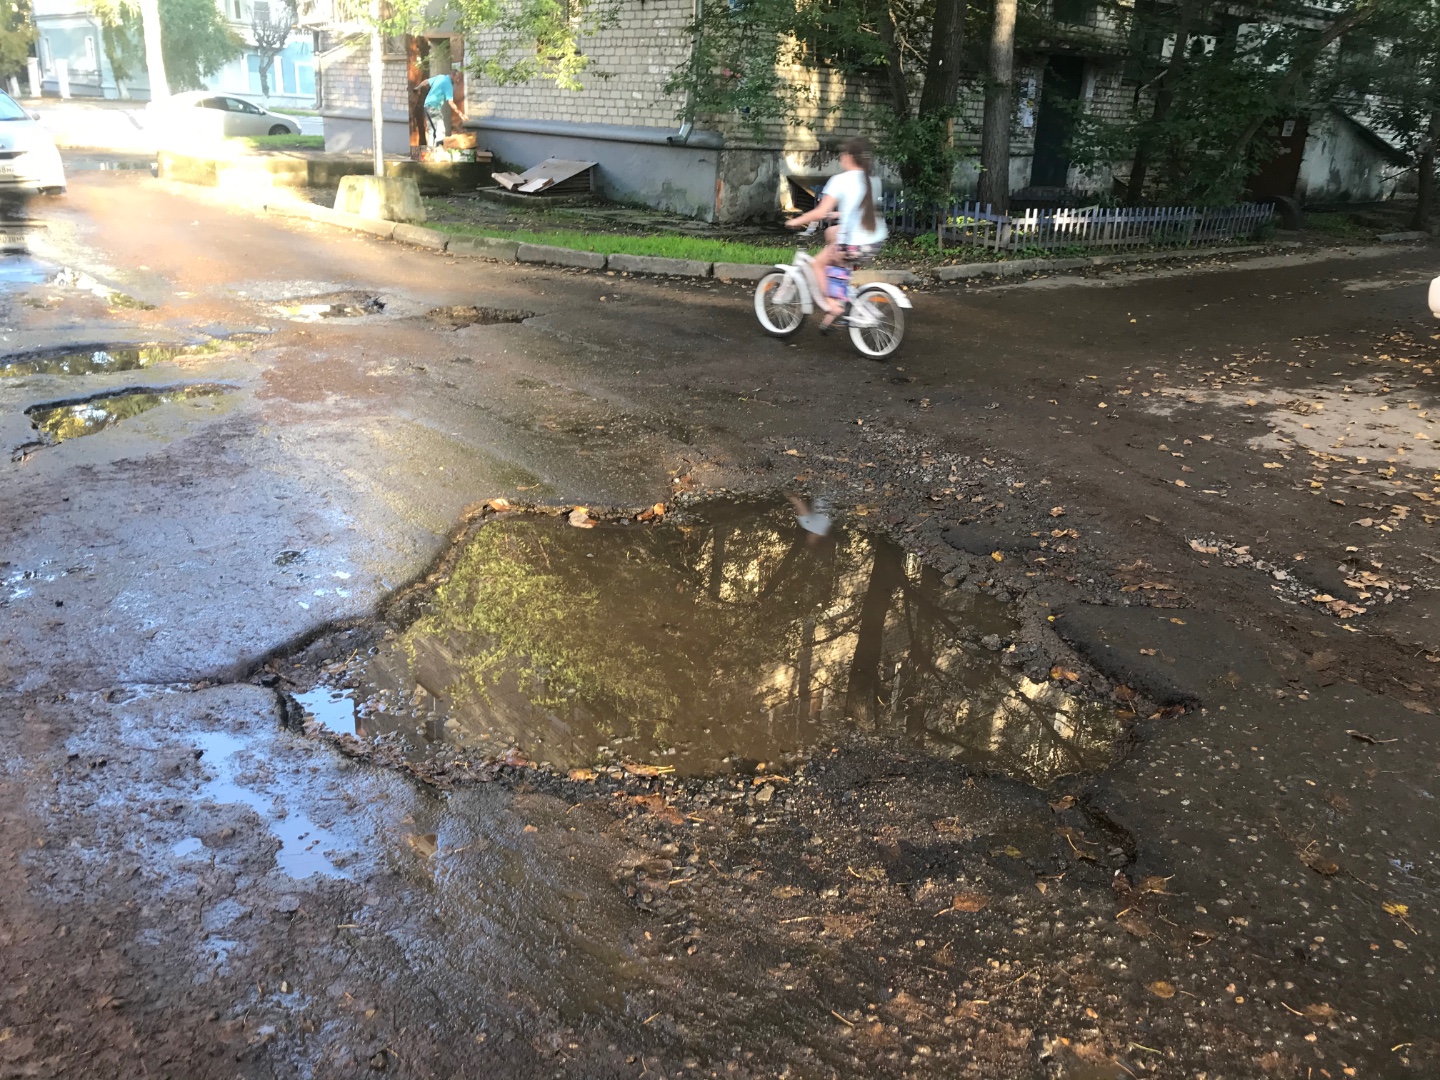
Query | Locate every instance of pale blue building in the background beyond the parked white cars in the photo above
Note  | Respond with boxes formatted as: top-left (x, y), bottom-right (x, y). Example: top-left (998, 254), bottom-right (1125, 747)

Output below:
top-left (32, 0), bottom-right (315, 109)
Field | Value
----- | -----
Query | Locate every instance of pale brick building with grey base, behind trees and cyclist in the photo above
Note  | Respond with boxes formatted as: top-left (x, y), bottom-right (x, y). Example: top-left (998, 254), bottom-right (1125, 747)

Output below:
top-left (317, 0), bottom-right (1394, 222)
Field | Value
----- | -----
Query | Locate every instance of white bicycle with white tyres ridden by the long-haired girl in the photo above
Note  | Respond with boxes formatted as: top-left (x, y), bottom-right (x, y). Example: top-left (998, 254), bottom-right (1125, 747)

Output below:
top-left (755, 251), bottom-right (912, 360)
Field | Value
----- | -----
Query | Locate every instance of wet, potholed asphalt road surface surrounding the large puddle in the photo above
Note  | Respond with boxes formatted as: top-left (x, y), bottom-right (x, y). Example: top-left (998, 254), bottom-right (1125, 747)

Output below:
top-left (0, 164), bottom-right (1440, 1077)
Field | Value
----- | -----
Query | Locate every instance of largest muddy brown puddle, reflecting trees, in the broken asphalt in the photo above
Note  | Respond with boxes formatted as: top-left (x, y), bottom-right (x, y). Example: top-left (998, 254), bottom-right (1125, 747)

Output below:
top-left (300, 504), bottom-right (1120, 783)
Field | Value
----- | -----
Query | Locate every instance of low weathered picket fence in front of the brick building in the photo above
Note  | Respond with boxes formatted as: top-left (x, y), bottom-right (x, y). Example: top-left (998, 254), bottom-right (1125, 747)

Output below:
top-left (884, 193), bottom-right (1274, 251)
